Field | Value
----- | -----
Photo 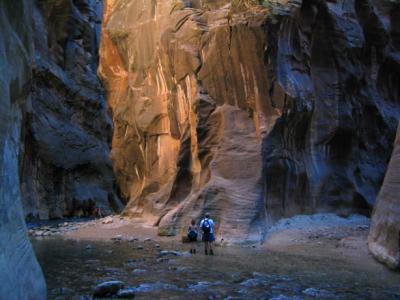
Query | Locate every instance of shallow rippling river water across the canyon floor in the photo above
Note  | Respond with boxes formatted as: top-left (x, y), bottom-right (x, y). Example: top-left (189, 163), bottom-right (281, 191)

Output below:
top-left (32, 238), bottom-right (400, 300)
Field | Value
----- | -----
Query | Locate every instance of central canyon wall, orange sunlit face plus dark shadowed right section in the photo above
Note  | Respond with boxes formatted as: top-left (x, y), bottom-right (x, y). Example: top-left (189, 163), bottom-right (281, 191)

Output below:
top-left (99, 0), bottom-right (400, 240)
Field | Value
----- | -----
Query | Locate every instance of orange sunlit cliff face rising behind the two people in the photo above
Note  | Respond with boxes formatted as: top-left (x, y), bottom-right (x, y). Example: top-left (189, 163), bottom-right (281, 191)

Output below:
top-left (99, 0), bottom-right (282, 239)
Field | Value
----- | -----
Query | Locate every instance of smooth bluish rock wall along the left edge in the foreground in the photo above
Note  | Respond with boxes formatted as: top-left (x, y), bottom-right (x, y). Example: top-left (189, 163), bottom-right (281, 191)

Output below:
top-left (0, 0), bottom-right (46, 299)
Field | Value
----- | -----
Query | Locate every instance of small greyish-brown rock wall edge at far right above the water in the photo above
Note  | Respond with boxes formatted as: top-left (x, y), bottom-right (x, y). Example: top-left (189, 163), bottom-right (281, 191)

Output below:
top-left (368, 125), bottom-right (400, 269)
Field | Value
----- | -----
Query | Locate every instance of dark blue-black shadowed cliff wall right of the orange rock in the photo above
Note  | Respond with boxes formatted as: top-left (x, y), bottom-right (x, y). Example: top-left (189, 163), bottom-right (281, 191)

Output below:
top-left (263, 0), bottom-right (400, 219)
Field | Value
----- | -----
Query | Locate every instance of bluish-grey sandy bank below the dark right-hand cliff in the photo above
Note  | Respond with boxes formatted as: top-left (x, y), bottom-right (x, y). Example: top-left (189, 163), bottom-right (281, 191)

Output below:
top-left (261, 214), bottom-right (385, 269)
